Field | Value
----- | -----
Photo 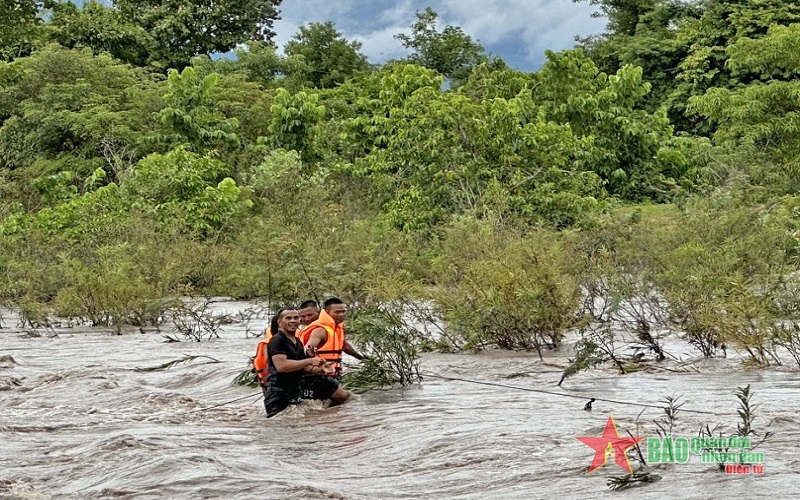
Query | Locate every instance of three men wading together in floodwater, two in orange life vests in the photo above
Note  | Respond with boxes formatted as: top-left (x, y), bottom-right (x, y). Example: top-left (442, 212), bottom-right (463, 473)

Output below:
top-left (253, 297), bottom-right (364, 418)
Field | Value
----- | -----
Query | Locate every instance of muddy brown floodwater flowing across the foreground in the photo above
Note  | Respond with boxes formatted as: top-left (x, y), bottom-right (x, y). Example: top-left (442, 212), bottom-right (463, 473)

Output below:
top-left (0, 302), bottom-right (800, 499)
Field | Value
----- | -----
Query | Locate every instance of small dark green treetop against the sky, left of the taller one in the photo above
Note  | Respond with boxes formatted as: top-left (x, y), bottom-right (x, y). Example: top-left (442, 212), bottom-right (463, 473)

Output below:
top-left (284, 21), bottom-right (369, 88)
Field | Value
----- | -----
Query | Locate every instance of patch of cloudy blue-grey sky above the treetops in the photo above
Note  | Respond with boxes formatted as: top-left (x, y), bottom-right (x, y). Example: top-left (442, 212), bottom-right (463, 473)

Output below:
top-left (275, 0), bottom-right (605, 71)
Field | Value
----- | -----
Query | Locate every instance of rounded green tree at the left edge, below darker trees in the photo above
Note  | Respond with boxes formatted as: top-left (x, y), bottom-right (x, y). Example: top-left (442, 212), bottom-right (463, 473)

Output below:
top-left (0, 46), bottom-right (163, 206)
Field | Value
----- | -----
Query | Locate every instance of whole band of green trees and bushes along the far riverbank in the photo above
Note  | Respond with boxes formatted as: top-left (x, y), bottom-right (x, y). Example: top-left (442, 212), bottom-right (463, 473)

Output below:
top-left (0, 0), bottom-right (800, 383)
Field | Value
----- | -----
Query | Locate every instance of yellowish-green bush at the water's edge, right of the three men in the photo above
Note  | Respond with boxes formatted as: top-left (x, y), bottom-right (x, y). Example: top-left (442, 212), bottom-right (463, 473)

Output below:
top-left (429, 219), bottom-right (579, 356)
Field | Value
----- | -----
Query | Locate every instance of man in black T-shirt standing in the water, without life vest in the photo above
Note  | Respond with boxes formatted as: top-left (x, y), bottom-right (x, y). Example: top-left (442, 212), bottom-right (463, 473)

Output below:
top-left (264, 307), bottom-right (348, 418)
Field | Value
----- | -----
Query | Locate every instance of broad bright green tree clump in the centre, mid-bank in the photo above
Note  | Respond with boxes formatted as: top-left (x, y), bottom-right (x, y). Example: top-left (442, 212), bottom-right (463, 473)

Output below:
top-left (338, 65), bottom-right (602, 231)
